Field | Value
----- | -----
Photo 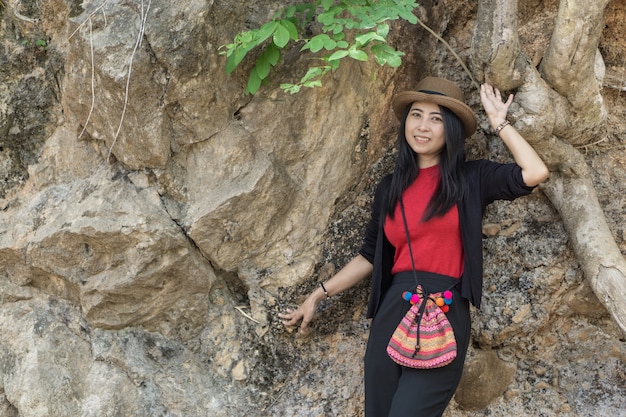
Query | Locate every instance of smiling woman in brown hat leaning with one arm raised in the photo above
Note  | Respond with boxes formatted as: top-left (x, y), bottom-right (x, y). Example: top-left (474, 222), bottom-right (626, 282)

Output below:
top-left (279, 77), bottom-right (548, 417)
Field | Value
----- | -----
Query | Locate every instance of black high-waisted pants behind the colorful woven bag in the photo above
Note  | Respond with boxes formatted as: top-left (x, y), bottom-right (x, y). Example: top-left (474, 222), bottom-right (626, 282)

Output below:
top-left (365, 272), bottom-right (471, 417)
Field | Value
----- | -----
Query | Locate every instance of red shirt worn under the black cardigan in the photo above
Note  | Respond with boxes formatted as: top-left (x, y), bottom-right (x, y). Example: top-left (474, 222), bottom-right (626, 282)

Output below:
top-left (384, 165), bottom-right (464, 278)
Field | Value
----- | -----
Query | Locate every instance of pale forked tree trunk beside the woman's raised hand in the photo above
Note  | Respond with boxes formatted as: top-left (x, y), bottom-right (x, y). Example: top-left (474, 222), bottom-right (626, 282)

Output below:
top-left (471, 0), bottom-right (626, 334)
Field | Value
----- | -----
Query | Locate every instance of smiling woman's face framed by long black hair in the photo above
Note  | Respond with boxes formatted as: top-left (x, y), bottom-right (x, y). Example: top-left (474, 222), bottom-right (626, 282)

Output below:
top-left (404, 101), bottom-right (446, 168)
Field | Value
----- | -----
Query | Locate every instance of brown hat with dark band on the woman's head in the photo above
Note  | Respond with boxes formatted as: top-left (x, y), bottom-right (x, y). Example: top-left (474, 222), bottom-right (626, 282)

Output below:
top-left (391, 77), bottom-right (476, 138)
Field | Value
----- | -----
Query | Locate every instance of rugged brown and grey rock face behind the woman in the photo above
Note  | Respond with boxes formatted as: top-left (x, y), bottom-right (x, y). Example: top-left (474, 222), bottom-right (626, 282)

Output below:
top-left (0, 0), bottom-right (626, 417)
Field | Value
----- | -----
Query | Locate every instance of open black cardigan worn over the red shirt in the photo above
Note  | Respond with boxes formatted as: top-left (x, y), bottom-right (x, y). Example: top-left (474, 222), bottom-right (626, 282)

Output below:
top-left (359, 159), bottom-right (534, 318)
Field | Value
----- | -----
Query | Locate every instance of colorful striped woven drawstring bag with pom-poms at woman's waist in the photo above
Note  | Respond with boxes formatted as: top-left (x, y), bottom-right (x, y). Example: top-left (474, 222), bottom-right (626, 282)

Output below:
top-left (387, 287), bottom-right (457, 369)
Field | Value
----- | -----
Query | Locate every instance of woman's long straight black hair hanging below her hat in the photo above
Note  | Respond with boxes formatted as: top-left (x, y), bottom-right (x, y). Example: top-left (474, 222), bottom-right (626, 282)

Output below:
top-left (385, 104), bottom-right (465, 221)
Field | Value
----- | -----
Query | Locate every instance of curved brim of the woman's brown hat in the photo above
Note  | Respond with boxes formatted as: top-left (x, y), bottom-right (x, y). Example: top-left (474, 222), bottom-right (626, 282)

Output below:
top-left (392, 91), bottom-right (476, 138)
